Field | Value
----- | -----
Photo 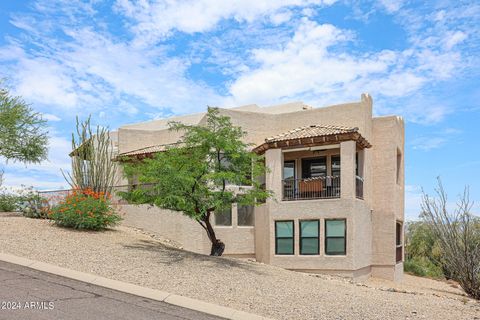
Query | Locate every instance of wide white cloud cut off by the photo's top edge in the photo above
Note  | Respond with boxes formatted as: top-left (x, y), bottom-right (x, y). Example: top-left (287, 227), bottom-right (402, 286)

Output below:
top-left (116, 0), bottom-right (335, 43)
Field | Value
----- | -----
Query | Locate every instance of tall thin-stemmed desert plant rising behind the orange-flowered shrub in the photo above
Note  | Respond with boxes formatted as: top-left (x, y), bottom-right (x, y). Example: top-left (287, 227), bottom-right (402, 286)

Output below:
top-left (62, 117), bottom-right (118, 193)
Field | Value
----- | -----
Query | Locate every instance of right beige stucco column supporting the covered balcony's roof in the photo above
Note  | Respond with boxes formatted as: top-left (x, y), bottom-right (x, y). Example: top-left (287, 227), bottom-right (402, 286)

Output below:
top-left (340, 141), bottom-right (357, 199)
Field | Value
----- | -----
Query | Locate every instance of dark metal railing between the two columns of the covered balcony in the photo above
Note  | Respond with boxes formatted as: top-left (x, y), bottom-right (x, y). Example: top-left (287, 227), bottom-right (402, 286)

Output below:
top-left (283, 176), bottom-right (340, 200)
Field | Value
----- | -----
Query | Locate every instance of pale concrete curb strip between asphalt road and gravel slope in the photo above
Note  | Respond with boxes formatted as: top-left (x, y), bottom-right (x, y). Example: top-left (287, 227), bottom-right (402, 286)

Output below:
top-left (0, 253), bottom-right (271, 320)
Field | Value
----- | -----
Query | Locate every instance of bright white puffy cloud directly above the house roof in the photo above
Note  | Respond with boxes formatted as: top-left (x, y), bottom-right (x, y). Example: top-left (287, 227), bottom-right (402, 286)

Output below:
top-left (230, 19), bottom-right (388, 104)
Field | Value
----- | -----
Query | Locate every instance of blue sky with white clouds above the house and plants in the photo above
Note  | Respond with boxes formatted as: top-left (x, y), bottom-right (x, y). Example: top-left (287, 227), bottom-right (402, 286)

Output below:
top-left (0, 0), bottom-right (480, 218)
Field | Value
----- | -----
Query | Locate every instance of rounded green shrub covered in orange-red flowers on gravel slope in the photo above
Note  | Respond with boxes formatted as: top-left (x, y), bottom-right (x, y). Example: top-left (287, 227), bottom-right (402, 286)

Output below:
top-left (49, 189), bottom-right (121, 230)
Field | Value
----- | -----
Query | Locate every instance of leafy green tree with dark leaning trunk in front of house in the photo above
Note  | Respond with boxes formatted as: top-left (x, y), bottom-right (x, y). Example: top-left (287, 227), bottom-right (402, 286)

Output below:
top-left (123, 108), bottom-right (271, 256)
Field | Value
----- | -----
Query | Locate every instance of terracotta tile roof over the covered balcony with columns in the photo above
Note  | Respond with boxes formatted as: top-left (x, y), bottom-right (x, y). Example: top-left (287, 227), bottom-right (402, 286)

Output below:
top-left (265, 125), bottom-right (358, 143)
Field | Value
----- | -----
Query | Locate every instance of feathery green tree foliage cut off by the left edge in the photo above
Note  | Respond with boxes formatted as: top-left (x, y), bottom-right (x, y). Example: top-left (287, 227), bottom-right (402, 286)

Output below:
top-left (0, 82), bottom-right (48, 163)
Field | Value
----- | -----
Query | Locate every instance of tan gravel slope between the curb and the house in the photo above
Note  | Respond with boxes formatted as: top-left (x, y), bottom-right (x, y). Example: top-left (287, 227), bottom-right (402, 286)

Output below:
top-left (0, 214), bottom-right (480, 320)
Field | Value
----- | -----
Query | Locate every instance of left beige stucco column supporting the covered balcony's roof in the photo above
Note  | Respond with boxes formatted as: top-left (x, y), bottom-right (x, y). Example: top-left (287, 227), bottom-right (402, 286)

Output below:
top-left (265, 149), bottom-right (283, 201)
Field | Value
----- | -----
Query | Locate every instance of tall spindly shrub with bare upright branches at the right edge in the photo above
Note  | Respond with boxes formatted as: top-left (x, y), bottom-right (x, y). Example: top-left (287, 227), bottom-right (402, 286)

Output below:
top-left (422, 179), bottom-right (480, 300)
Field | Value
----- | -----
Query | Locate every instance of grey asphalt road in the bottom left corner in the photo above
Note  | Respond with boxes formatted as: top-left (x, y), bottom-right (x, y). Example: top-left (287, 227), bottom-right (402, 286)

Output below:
top-left (0, 261), bottom-right (221, 320)
